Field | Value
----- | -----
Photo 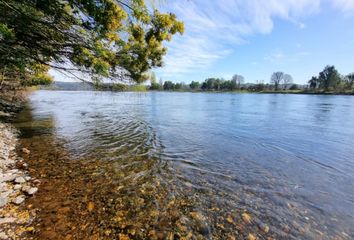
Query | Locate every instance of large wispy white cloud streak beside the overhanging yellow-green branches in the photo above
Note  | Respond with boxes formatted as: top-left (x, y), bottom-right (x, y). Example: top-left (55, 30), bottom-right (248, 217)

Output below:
top-left (159, 0), bottom-right (320, 77)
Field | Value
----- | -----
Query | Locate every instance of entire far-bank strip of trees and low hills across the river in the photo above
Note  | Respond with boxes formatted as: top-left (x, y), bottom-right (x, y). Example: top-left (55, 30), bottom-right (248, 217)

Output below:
top-left (42, 66), bottom-right (354, 94)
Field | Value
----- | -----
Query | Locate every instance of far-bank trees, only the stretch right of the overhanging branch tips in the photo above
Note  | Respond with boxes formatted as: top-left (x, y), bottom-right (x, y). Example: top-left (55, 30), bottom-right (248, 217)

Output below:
top-left (148, 66), bottom-right (354, 93)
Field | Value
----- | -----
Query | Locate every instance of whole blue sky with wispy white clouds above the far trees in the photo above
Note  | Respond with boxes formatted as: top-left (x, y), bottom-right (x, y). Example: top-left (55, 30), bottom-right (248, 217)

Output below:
top-left (154, 0), bottom-right (354, 83)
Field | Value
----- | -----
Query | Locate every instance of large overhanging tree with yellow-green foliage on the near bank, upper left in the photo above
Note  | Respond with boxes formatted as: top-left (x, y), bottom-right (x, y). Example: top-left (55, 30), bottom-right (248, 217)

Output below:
top-left (0, 0), bottom-right (184, 87)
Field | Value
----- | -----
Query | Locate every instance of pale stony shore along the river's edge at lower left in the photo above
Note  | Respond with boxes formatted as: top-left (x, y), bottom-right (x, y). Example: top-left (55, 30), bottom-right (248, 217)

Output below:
top-left (0, 122), bottom-right (39, 240)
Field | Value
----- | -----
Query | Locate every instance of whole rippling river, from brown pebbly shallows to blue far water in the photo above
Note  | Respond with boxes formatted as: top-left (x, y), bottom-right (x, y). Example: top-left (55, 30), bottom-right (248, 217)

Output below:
top-left (13, 91), bottom-right (354, 239)
